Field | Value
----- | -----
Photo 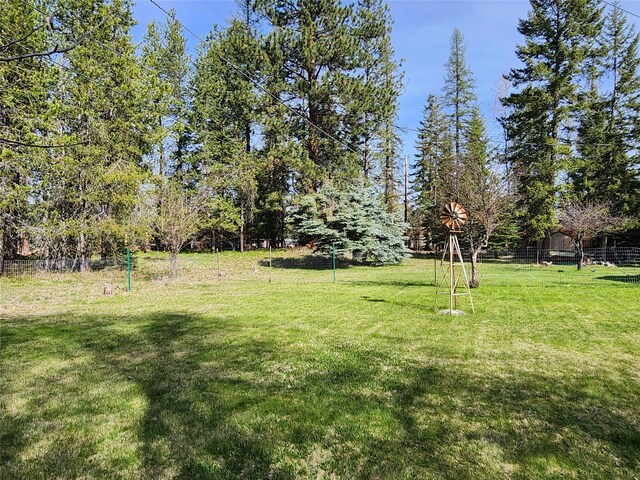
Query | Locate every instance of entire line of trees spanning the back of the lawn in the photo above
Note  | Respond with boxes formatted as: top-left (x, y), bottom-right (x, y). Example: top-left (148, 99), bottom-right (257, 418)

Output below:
top-left (0, 0), bottom-right (640, 268)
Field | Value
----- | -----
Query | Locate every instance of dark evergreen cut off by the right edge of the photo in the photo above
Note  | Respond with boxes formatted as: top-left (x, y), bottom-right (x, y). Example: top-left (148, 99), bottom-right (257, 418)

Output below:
top-left (570, 4), bottom-right (640, 225)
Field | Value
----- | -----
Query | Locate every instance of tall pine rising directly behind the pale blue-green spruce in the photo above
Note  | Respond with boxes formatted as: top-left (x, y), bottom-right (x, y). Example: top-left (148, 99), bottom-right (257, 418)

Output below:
top-left (256, 0), bottom-right (360, 191)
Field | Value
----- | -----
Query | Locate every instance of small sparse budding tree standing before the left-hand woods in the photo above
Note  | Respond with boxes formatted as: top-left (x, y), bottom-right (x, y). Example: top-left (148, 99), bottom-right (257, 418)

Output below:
top-left (156, 183), bottom-right (200, 278)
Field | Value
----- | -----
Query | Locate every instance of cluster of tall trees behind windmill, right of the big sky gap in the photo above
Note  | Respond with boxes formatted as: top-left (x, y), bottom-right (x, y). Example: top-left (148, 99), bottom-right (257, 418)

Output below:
top-left (412, 0), bottom-right (640, 258)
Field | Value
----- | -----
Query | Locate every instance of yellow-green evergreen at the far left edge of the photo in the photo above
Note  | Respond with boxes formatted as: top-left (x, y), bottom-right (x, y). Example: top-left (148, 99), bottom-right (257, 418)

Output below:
top-left (0, 0), bottom-right (58, 266)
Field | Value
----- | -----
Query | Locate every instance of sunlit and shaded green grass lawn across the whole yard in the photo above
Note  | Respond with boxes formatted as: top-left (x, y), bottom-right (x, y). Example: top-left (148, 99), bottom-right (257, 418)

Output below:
top-left (0, 252), bottom-right (640, 480)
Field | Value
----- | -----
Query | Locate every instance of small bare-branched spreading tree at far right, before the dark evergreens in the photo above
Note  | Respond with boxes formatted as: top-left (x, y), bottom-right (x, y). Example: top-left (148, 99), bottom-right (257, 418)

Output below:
top-left (559, 201), bottom-right (627, 270)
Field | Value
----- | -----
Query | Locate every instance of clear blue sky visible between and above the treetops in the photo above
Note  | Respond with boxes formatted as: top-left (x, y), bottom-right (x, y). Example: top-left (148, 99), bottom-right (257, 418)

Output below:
top-left (134, 0), bottom-right (640, 158)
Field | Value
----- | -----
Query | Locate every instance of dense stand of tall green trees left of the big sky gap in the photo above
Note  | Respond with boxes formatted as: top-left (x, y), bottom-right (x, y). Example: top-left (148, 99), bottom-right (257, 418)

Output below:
top-left (0, 0), bottom-right (402, 264)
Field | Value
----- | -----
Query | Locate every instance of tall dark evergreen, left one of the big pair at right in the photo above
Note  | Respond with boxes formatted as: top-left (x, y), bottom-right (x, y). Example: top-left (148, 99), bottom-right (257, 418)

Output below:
top-left (503, 0), bottom-right (601, 239)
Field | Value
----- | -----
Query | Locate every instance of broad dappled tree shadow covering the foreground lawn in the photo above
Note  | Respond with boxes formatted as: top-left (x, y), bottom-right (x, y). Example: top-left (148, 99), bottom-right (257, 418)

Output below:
top-left (0, 313), bottom-right (640, 479)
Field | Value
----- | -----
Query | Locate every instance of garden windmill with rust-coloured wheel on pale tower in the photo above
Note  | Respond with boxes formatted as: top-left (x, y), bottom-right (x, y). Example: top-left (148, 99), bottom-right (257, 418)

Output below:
top-left (436, 202), bottom-right (476, 315)
